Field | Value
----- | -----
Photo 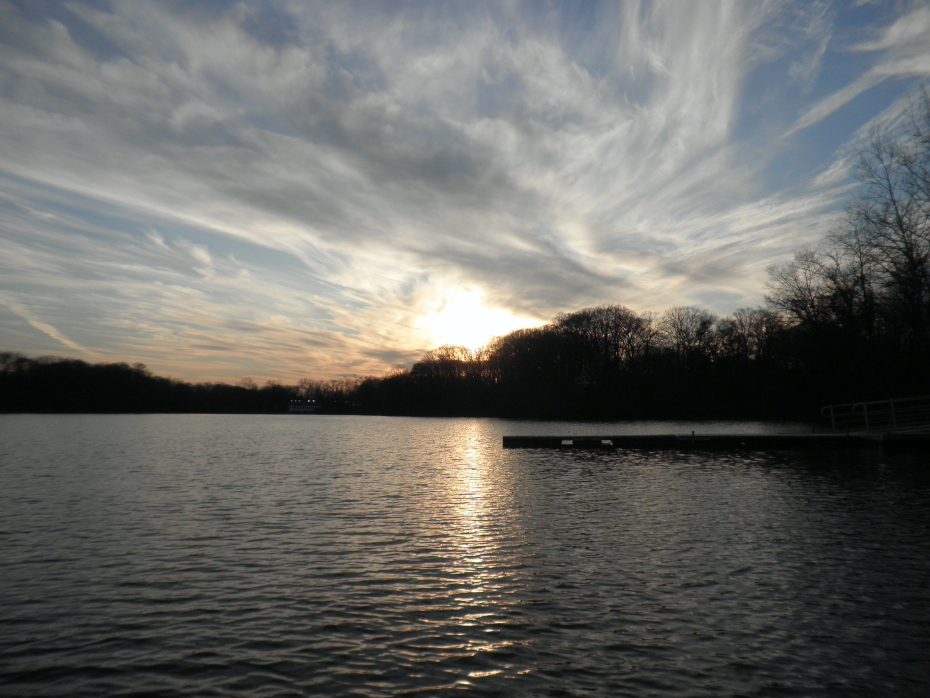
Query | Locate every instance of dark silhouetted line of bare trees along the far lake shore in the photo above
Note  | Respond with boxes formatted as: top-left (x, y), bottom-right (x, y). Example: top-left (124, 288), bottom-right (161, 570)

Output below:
top-left (0, 91), bottom-right (930, 421)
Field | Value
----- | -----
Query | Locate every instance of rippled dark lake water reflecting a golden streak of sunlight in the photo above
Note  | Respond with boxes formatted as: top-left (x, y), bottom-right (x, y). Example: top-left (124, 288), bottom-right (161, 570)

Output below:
top-left (0, 415), bottom-right (930, 696)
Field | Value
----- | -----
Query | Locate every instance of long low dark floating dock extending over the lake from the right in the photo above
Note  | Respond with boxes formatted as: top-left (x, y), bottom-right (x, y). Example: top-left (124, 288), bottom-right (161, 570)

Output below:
top-left (504, 432), bottom-right (930, 451)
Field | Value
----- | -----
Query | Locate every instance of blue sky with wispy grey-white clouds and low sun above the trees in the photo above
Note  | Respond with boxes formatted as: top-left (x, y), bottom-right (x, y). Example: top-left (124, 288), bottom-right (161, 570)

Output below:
top-left (0, 0), bottom-right (930, 383)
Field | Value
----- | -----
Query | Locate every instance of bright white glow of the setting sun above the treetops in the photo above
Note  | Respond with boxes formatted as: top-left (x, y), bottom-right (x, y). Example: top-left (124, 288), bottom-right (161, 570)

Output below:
top-left (423, 289), bottom-right (539, 351)
